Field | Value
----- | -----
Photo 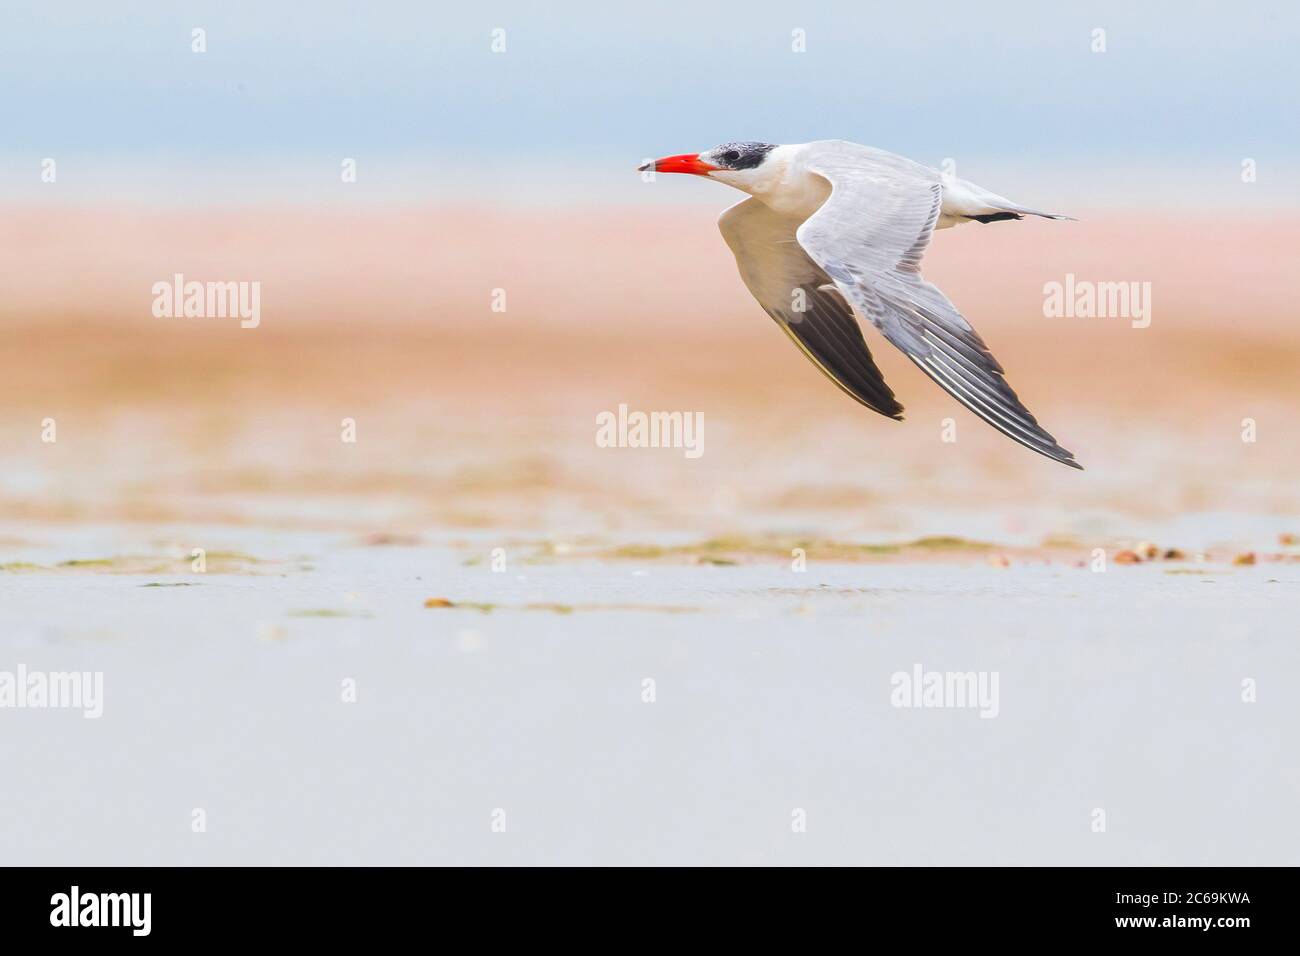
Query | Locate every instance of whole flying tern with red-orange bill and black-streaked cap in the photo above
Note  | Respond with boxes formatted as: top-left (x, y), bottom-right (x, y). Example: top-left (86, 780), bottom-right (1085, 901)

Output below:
top-left (638, 139), bottom-right (1083, 468)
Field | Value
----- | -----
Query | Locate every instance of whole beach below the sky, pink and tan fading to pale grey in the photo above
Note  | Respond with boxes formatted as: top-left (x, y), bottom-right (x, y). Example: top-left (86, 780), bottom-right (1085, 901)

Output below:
top-left (0, 206), bottom-right (1300, 865)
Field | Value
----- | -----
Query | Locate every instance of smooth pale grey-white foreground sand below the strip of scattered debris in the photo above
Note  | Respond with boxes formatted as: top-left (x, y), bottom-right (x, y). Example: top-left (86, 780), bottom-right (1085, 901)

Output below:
top-left (0, 527), bottom-right (1300, 865)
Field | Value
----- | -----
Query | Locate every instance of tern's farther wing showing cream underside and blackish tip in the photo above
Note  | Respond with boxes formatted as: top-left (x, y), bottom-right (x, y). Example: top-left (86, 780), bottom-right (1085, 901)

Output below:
top-left (718, 199), bottom-right (902, 419)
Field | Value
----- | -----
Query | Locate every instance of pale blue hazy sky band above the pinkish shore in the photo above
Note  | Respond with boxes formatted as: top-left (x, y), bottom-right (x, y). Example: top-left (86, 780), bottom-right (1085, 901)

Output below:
top-left (0, 0), bottom-right (1300, 199)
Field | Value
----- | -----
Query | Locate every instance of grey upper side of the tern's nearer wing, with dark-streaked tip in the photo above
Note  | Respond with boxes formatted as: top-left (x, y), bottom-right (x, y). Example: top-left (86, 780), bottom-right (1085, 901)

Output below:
top-left (796, 143), bottom-right (1082, 468)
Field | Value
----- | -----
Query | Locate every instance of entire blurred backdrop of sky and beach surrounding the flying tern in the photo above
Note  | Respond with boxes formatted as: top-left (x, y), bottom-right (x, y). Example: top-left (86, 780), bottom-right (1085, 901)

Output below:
top-left (0, 0), bottom-right (1300, 862)
